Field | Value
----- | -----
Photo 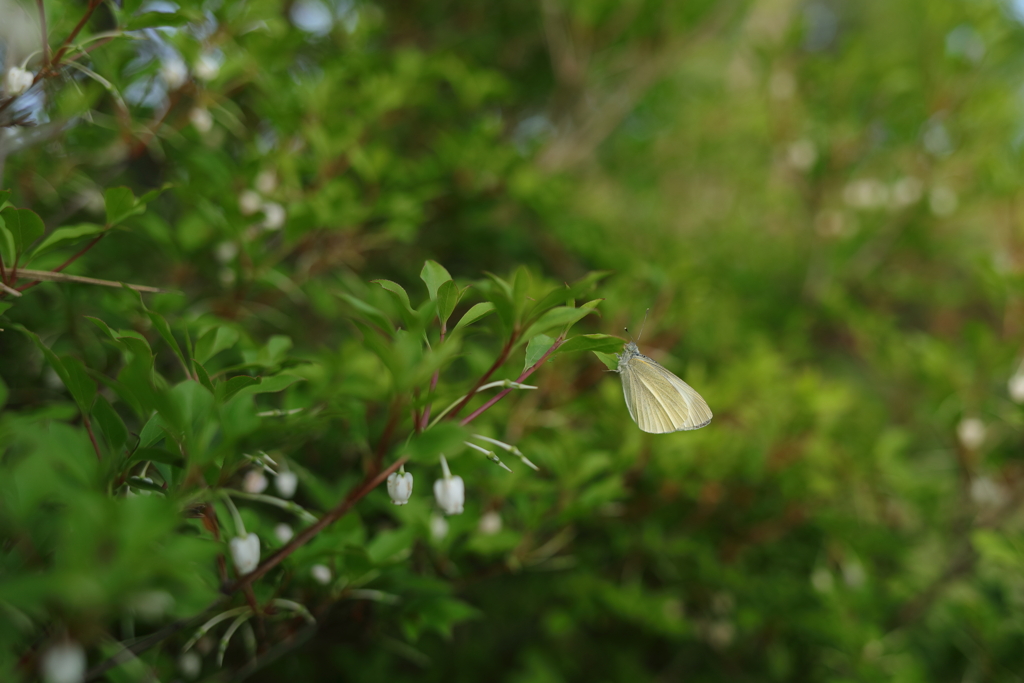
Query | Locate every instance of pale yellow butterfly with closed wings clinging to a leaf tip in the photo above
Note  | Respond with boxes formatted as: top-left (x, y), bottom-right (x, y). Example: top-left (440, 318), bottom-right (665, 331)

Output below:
top-left (616, 342), bottom-right (712, 434)
